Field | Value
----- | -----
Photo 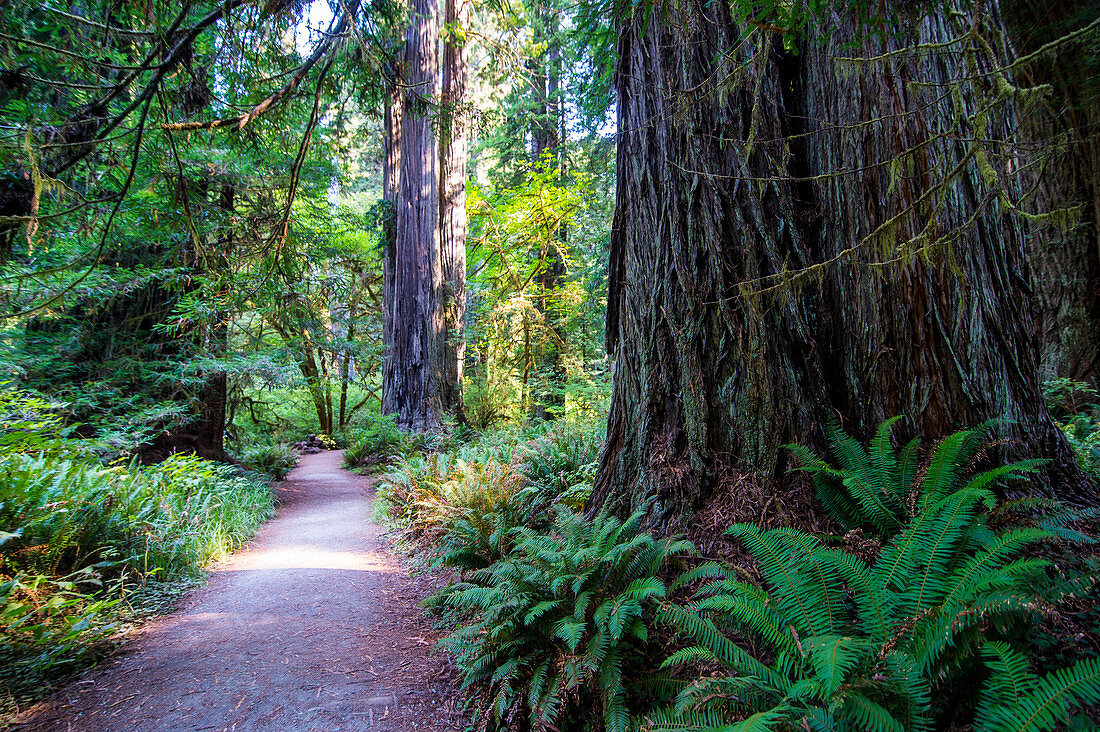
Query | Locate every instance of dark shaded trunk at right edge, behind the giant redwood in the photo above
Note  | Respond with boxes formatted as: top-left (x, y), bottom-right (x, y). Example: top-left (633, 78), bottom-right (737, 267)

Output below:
top-left (1002, 0), bottom-right (1100, 386)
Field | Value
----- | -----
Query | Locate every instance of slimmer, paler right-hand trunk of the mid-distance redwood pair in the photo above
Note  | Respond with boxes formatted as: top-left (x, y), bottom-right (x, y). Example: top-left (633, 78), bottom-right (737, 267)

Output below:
top-left (439, 0), bottom-right (470, 420)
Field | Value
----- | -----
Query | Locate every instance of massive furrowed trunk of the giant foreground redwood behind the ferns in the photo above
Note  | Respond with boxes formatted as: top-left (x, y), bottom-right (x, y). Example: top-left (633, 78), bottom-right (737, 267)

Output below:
top-left (592, 0), bottom-right (1092, 523)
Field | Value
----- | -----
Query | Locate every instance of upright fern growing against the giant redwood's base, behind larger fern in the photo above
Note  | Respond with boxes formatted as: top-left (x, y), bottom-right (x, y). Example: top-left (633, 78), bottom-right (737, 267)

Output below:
top-left (787, 417), bottom-right (1046, 538)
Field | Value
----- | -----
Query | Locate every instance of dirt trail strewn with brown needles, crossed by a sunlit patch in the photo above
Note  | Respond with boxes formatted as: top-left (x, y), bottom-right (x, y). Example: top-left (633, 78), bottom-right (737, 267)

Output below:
top-left (18, 451), bottom-right (466, 732)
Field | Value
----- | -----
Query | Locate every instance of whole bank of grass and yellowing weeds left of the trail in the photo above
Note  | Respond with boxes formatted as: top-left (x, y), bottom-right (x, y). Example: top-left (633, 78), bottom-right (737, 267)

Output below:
top-left (0, 387), bottom-right (274, 721)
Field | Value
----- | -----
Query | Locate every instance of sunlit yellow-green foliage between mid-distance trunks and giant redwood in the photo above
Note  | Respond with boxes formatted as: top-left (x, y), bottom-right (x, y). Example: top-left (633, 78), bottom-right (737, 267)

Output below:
top-left (465, 159), bottom-right (604, 428)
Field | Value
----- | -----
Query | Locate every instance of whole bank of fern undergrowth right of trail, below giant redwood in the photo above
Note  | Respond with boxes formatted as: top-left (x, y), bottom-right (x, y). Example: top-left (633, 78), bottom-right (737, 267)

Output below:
top-left (380, 420), bottom-right (1100, 732)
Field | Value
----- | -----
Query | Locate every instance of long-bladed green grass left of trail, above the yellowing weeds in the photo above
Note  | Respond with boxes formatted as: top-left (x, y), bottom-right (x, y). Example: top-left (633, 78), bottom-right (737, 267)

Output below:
top-left (0, 455), bottom-right (272, 577)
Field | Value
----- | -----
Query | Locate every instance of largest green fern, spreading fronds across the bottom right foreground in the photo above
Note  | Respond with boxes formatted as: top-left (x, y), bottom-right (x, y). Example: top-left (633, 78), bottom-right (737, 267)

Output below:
top-left (641, 471), bottom-right (1100, 732)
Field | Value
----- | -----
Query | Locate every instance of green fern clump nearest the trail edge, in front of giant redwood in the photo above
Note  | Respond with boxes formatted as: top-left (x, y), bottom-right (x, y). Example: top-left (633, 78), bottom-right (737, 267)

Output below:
top-left (436, 509), bottom-right (692, 732)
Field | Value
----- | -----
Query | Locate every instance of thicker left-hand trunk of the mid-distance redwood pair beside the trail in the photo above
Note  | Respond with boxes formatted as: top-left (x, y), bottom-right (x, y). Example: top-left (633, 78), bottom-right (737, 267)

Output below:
top-left (382, 0), bottom-right (443, 431)
